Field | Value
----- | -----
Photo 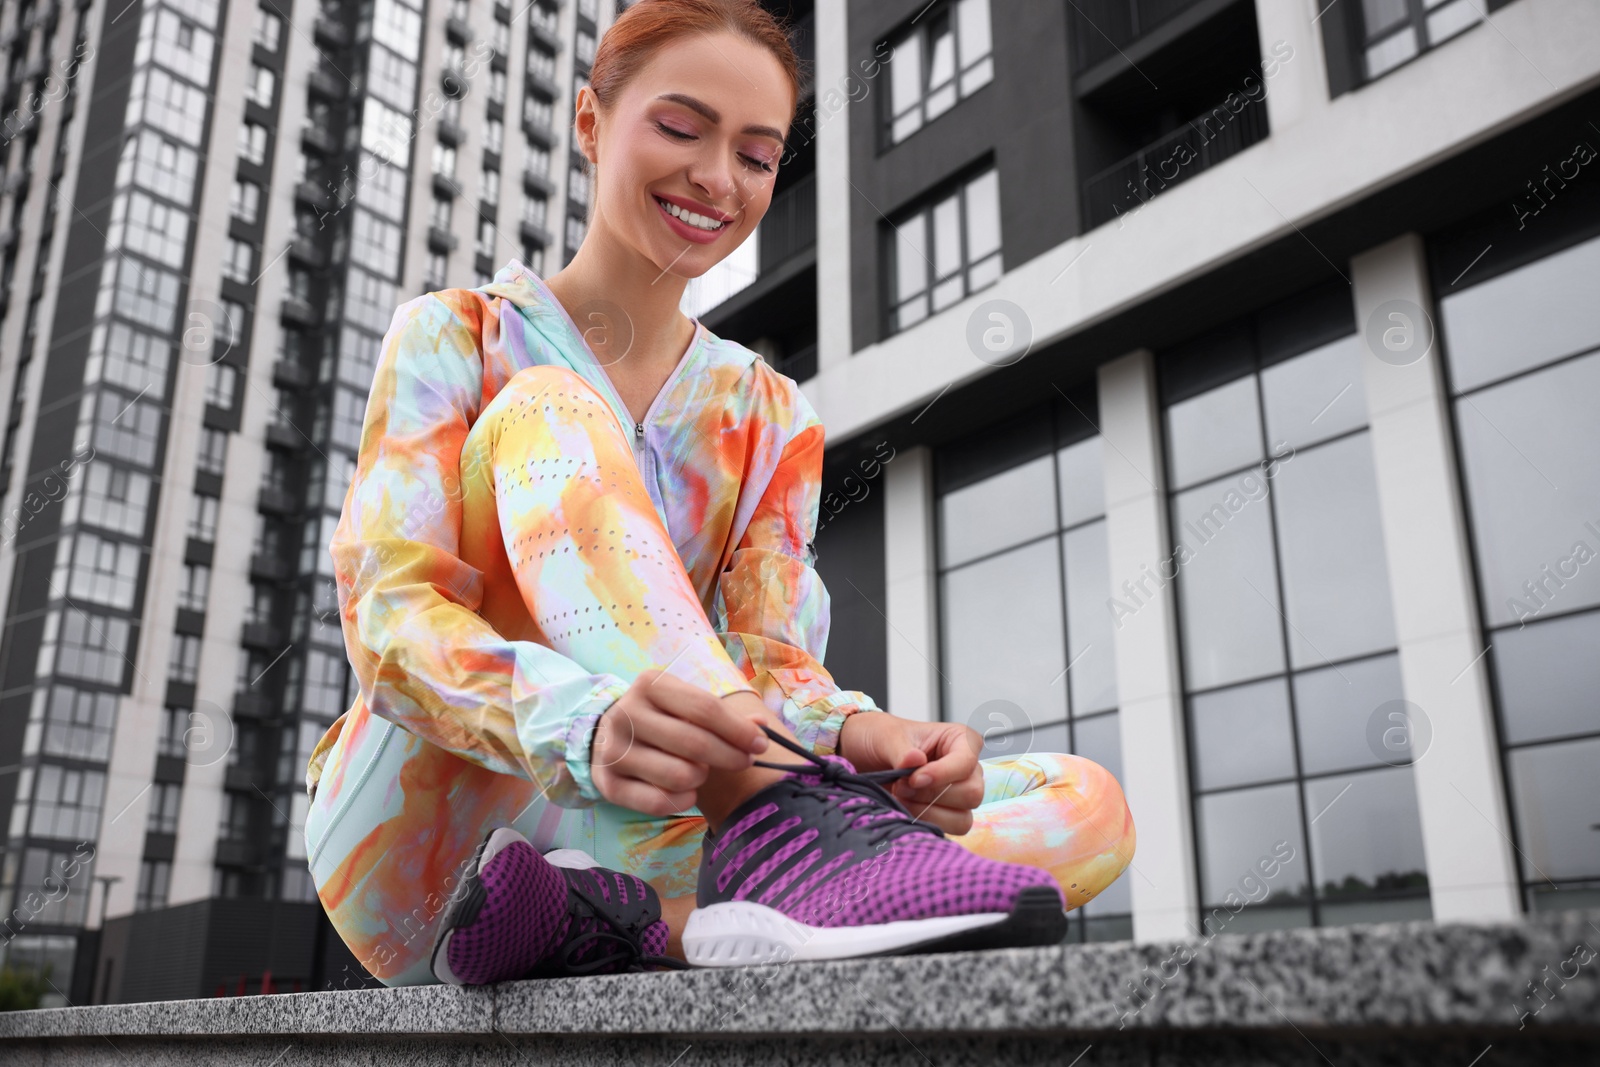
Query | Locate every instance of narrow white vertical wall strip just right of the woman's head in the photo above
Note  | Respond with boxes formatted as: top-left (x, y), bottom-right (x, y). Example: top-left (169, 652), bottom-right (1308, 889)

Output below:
top-left (811, 0), bottom-right (851, 375)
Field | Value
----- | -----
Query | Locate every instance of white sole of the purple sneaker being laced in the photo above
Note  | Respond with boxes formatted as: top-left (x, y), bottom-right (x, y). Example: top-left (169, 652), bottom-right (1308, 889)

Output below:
top-left (683, 901), bottom-right (1011, 966)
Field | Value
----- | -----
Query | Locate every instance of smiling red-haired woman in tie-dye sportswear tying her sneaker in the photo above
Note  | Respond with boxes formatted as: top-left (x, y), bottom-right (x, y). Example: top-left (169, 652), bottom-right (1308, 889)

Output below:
top-left (306, 0), bottom-right (1134, 985)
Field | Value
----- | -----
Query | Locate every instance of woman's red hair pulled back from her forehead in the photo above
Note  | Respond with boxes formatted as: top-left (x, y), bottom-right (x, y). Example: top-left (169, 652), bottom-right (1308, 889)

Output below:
top-left (589, 0), bottom-right (800, 125)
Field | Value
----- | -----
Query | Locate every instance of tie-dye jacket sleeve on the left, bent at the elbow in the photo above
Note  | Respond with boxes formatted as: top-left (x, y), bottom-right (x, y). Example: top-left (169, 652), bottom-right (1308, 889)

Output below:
top-left (328, 290), bottom-right (627, 806)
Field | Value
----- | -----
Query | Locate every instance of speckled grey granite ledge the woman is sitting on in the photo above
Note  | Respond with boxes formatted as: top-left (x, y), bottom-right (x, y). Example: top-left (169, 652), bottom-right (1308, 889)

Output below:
top-left (0, 910), bottom-right (1600, 1059)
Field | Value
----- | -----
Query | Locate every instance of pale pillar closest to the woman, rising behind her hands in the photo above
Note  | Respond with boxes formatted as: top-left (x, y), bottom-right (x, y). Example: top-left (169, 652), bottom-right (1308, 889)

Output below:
top-left (883, 445), bottom-right (939, 721)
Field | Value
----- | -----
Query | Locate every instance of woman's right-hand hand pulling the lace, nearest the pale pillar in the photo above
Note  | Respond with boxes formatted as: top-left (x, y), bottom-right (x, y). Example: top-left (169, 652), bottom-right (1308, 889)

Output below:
top-left (838, 712), bottom-right (984, 833)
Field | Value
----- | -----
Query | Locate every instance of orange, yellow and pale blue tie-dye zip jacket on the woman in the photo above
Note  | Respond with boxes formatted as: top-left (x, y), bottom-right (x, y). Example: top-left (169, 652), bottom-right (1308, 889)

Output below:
top-left (306, 261), bottom-right (877, 806)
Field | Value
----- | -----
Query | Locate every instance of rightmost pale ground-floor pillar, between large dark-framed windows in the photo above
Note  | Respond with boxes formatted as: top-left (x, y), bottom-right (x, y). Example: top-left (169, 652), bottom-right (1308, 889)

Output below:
top-left (1350, 234), bottom-right (1522, 921)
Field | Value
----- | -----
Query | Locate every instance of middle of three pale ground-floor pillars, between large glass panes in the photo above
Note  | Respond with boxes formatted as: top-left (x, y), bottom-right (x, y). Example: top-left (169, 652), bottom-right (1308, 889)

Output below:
top-left (1099, 349), bottom-right (1200, 941)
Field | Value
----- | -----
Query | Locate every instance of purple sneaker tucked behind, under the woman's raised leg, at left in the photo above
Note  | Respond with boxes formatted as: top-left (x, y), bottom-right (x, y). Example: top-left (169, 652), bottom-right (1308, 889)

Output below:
top-left (430, 827), bottom-right (683, 985)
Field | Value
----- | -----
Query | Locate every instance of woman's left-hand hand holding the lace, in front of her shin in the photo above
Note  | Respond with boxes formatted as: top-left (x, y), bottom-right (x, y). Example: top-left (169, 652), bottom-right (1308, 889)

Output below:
top-left (589, 670), bottom-right (768, 816)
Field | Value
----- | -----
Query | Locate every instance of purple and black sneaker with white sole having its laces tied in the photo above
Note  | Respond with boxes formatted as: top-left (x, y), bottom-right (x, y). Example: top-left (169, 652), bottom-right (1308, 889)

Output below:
top-left (683, 729), bottom-right (1067, 966)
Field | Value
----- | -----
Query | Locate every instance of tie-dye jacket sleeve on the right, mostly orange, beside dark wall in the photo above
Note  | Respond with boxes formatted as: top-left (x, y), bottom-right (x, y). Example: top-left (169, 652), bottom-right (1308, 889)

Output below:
top-left (714, 412), bottom-right (882, 755)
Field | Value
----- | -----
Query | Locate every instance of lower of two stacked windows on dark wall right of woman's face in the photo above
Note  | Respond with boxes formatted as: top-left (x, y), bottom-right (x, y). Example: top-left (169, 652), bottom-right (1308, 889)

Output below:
top-left (888, 170), bottom-right (1002, 333)
